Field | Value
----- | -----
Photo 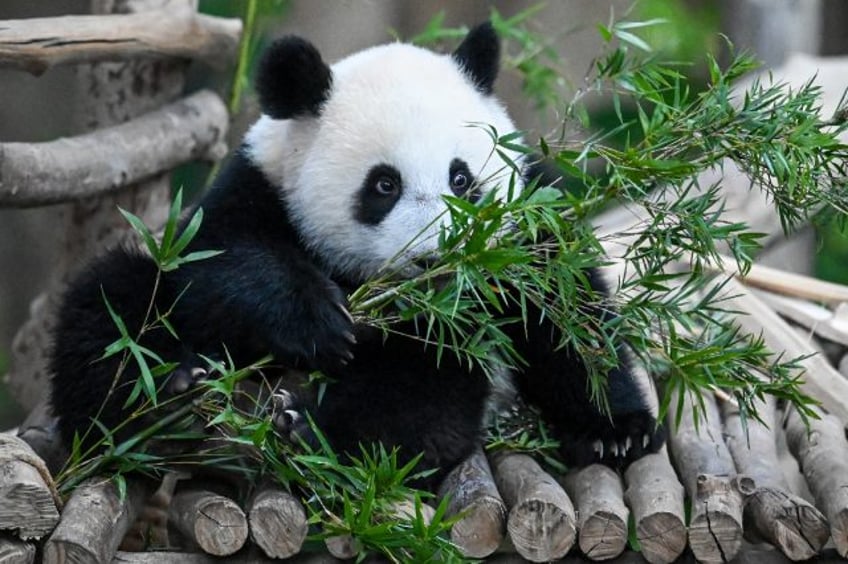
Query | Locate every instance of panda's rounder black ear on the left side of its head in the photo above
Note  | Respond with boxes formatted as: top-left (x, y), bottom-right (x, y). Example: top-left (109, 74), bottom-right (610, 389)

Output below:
top-left (256, 36), bottom-right (332, 119)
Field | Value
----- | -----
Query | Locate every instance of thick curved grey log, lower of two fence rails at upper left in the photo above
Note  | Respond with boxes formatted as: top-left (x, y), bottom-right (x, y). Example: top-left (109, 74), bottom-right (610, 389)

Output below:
top-left (0, 91), bottom-right (228, 207)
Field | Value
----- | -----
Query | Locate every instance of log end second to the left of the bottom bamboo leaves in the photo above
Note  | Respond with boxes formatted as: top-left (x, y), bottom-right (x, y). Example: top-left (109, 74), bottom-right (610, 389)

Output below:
top-left (168, 489), bottom-right (248, 556)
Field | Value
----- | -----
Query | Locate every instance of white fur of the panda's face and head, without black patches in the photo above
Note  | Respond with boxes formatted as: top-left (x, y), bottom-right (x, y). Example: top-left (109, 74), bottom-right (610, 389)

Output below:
top-left (247, 43), bottom-right (521, 277)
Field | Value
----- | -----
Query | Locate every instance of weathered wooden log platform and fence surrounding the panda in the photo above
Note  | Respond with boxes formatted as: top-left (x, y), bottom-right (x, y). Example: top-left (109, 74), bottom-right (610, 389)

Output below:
top-left (0, 0), bottom-right (848, 564)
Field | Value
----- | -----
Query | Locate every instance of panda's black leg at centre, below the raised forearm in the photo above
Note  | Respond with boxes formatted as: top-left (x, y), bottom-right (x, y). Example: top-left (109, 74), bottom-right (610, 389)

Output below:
top-left (304, 328), bottom-right (489, 488)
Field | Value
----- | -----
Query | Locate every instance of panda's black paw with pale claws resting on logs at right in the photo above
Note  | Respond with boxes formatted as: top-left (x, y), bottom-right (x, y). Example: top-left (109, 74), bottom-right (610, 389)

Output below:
top-left (561, 411), bottom-right (665, 470)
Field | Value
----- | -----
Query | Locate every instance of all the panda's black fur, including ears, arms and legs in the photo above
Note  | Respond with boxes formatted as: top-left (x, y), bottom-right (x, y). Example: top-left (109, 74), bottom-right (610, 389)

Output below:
top-left (50, 26), bottom-right (662, 486)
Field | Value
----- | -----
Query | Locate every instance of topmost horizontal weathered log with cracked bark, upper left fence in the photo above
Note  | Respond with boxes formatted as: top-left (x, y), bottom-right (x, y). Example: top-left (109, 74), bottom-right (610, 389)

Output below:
top-left (0, 6), bottom-right (242, 75)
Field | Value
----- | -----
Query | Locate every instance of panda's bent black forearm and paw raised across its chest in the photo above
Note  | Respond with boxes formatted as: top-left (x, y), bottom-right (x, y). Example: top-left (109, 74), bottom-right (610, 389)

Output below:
top-left (174, 238), bottom-right (353, 370)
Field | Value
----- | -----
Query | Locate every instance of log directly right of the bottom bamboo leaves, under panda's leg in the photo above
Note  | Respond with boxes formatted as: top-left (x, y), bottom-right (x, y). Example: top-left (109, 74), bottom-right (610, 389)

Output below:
top-left (439, 448), bottom-right (507, 558)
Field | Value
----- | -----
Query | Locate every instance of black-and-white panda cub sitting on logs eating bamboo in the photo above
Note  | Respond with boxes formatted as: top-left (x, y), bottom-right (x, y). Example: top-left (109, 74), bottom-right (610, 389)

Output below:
top-left (50, 23), bottom-right (662, 484)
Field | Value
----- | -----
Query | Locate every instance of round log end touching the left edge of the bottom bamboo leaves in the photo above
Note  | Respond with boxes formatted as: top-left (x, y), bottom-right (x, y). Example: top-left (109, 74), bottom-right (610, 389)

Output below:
top-left (247, 485), bottom-right (308, 558)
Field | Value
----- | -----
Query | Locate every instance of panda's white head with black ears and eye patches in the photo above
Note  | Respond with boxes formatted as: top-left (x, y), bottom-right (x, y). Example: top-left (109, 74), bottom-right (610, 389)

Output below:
top-left (246, 24), bottom-right (521, 279)
